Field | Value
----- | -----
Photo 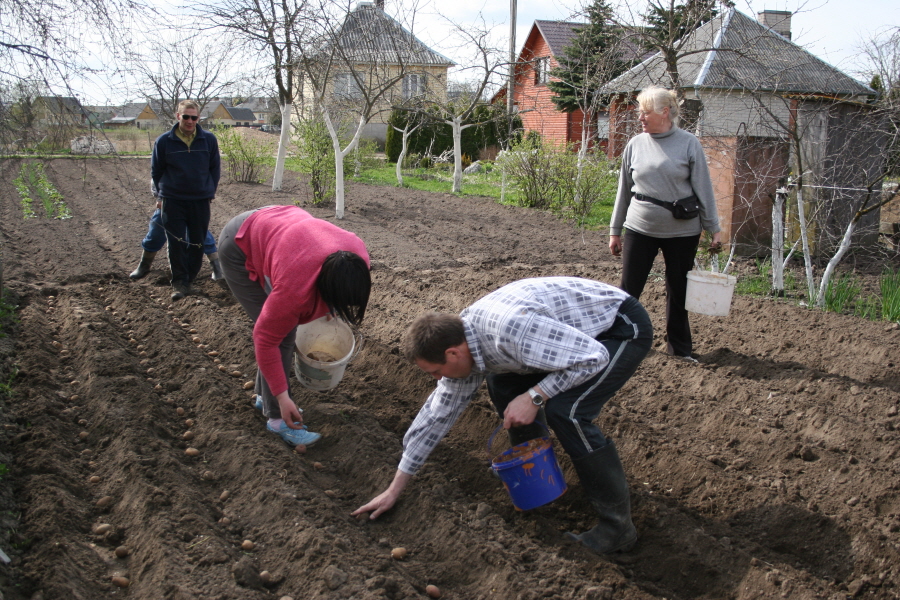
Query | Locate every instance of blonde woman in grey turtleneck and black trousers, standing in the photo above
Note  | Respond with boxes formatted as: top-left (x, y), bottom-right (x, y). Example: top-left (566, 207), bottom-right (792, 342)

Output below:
top-left (609, 87), bottom-right (721, 362)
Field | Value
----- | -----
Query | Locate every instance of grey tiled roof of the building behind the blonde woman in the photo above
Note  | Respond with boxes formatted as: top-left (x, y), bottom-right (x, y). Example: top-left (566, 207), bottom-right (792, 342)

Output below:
top-left (601, 9), bottom-right (875, 96)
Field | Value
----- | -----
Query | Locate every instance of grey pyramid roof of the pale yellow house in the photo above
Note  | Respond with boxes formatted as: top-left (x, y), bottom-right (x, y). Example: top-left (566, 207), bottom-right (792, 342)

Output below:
top-left (325, 2), bottom-right (454, 66)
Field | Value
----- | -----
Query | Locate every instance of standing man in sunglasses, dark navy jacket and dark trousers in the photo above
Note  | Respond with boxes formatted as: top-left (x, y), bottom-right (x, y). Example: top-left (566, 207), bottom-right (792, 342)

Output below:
top-left (150, 100), bottom-right (222, 300)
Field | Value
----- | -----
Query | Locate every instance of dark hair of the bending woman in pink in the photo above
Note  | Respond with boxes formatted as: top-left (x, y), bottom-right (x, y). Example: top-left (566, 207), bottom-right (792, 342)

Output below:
top-left (316, 250), bottom-right (372, 327)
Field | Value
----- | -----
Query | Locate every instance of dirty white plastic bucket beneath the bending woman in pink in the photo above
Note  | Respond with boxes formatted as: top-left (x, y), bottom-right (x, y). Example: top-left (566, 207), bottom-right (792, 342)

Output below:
top-left (294, 317), bottom-right (357, 391)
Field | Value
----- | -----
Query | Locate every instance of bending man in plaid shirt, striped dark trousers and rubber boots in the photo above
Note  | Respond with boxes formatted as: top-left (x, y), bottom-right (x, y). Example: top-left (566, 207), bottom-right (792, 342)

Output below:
top-left (353, 277), bottom-right (653, 554)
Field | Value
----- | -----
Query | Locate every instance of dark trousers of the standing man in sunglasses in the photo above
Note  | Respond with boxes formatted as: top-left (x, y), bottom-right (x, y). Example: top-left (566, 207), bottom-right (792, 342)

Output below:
top-left (160, 198), bottom-right (210, 285)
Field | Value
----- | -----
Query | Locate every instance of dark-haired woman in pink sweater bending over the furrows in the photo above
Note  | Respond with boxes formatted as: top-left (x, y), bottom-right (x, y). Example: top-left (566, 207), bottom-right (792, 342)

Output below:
top-left (219, 206), bottom-right (372, 446)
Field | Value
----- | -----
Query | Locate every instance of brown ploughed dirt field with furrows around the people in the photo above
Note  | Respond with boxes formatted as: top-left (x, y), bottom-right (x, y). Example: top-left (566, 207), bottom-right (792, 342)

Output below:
top-left (0, 158), bottom-right (900, 600)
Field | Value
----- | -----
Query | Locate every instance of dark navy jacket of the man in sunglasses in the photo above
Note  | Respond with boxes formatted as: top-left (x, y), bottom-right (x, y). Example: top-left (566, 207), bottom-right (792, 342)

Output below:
top-left (150, 123), bottom-right (222, 200)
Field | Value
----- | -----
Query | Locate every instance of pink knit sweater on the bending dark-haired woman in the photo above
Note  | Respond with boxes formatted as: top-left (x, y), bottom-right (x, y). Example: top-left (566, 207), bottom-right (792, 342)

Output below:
top-left (235, 206), bottom-right (371, 396)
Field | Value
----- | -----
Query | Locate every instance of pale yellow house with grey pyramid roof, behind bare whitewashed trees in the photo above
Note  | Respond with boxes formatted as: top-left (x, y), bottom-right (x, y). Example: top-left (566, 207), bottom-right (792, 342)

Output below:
top-left (291, 0), bottom-right (454, 143)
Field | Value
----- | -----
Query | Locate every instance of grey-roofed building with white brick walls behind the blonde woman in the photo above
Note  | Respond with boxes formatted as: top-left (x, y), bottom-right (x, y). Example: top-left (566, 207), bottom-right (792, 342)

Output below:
top-left (600, 9), bottom-right (882, 254)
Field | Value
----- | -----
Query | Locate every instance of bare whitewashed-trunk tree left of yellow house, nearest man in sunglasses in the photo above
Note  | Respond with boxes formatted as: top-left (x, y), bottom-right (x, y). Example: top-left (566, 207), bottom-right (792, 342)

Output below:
top-left (195, 0), bottom-right (314, 190)
